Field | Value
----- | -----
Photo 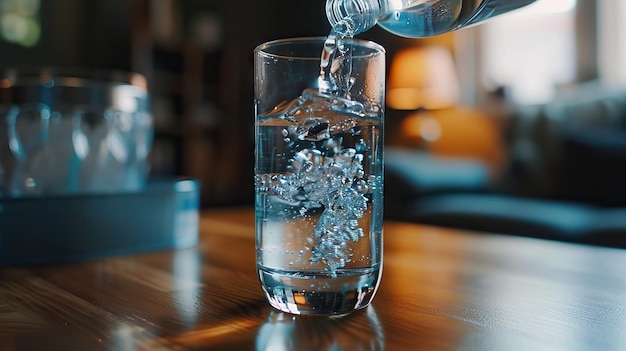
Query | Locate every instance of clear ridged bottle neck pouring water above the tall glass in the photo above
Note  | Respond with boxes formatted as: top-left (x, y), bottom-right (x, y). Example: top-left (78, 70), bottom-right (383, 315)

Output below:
top-left (326, 0), bottom-right (385, 36)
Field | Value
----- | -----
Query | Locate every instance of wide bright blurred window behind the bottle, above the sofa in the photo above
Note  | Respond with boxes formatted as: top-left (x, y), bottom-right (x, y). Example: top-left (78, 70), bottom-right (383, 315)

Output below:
top-left (476, 0), bottom-right (576, 104)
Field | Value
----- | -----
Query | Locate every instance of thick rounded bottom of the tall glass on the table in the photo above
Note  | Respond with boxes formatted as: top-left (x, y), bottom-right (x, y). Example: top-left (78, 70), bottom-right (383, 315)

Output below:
top-left (258, 266), bottom-right (380, 315)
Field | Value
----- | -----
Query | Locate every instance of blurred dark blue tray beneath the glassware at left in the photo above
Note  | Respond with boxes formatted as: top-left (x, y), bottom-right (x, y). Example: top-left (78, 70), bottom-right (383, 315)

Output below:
top-left (0, 179), bottom-right (200, 266)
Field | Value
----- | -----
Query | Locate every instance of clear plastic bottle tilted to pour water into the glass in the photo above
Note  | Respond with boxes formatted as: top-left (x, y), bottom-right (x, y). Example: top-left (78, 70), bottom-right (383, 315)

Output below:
top-left (326, 0), bottom-right (535, 38)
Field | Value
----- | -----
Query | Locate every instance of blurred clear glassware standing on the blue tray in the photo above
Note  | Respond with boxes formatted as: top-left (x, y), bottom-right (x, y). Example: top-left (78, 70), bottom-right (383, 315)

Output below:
top-left (0, 68), bottom-right (153, 197)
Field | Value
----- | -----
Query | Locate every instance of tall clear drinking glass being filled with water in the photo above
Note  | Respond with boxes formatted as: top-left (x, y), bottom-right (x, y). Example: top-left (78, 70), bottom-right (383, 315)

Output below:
top-left (254, 38), bottom-right (385, 315)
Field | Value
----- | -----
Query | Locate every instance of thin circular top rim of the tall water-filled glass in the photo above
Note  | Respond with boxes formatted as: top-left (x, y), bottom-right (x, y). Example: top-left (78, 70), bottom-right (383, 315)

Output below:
top-left (254, 36), bottom-right (386, 60)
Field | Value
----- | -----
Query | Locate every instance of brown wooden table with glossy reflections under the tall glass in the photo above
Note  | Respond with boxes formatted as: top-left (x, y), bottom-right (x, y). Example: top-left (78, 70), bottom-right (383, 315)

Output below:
top-left (0, 209), bottom-right (626, 351)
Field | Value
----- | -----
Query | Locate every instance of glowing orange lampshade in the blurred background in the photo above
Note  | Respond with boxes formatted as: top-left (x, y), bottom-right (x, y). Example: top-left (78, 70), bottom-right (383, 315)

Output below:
top-left (387, 45), bottom-right (459, 110)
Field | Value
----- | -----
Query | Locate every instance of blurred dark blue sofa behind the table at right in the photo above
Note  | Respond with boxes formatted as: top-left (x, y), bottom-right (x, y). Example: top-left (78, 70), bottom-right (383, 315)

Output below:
top-left (385, 82), bottom-right (626, 248)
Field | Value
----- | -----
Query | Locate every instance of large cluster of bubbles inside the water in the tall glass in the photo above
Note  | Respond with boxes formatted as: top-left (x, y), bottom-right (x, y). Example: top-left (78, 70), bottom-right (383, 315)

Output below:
top-left (272, 137), bottom-right (376, 274)
